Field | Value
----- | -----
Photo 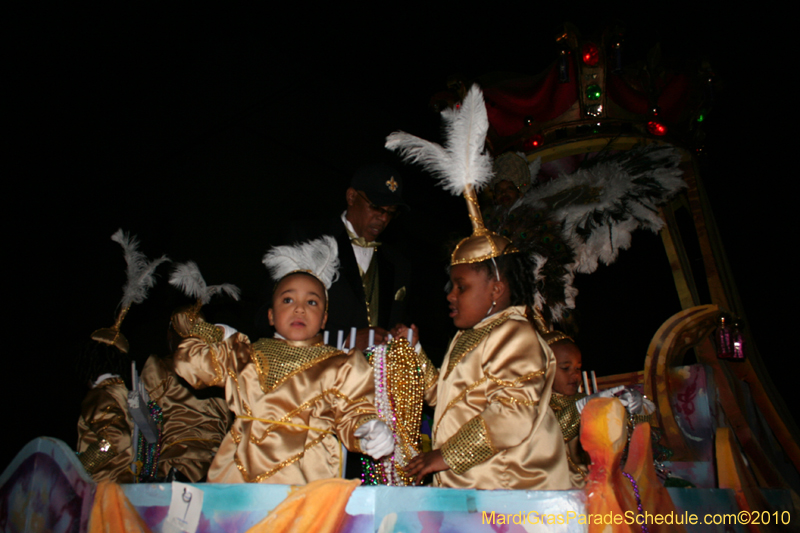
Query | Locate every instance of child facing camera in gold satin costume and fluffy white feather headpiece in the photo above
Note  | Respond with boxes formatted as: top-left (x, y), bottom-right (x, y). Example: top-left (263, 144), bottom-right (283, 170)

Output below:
top-left (173, 237), bottom-right (394, 485)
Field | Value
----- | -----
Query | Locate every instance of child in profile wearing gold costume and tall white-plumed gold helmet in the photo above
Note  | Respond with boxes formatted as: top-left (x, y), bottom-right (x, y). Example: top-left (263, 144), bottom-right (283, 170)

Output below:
top-left (386, 86), bottom-right (571, 490)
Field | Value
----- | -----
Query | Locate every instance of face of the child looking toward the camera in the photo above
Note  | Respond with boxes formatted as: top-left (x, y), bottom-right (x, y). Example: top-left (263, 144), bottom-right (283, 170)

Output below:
top-left (268, 274), bottom-right (328, 341)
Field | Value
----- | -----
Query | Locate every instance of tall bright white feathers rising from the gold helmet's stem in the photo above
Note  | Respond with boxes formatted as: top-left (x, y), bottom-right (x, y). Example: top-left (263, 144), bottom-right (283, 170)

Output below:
top-left (386, 85), bottom-right (492, 196)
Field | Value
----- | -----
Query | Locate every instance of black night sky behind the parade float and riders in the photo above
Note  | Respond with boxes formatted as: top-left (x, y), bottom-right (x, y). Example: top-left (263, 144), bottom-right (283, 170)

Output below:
top-left (0, 5), bottom-right (796, 466)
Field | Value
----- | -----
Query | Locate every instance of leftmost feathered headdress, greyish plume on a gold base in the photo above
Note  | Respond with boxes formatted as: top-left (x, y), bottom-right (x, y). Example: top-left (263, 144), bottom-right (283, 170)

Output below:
top-left (92, 229), bottom-right (169, 353)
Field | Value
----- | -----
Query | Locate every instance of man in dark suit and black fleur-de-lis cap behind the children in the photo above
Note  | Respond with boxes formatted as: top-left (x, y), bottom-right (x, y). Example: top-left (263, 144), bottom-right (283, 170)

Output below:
top-left (259, 165), bottom-right (411, 350)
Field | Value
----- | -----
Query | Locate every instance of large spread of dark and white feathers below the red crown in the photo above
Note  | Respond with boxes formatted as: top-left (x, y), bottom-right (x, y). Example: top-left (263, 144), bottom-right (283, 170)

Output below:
top-left (486, 144), bottom-right (686, 324)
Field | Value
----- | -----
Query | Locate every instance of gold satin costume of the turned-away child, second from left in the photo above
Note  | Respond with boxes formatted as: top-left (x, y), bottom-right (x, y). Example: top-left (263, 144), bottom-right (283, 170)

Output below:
top-left (141, 356), bottom-right (232, 483)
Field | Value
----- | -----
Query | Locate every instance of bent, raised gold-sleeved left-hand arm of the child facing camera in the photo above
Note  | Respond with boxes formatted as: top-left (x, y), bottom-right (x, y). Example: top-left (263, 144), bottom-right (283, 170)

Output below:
top-left (173, 316), bottom-right (251, 389)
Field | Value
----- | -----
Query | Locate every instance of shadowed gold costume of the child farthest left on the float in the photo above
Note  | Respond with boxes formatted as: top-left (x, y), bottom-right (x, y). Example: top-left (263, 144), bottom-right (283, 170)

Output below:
top-left (77, 377), bottom-right (133, 483)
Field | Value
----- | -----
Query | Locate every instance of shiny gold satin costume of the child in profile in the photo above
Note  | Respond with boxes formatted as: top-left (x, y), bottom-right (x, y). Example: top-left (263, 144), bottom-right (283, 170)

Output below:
top-left (422, 307), bottom-right (572, 490)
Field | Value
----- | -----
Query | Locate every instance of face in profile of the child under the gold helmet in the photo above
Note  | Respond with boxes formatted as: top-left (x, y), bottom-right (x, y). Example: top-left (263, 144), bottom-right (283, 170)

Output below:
top-left (447, 265), bottom-right (495, 329)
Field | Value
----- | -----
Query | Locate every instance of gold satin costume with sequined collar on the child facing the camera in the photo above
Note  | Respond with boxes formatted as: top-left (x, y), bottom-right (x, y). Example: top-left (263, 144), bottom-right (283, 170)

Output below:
top-left (174, 333), bottom-right (377, 485)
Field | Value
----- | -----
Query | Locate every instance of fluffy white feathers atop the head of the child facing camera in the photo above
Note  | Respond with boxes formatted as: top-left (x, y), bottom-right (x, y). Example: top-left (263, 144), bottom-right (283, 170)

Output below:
top-left (263, 235), bottom-right (339, 289)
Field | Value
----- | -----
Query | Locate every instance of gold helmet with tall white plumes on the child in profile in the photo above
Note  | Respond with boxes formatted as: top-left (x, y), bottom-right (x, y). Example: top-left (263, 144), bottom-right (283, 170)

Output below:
top-left (386, 85), bottom-right (517, 265)
